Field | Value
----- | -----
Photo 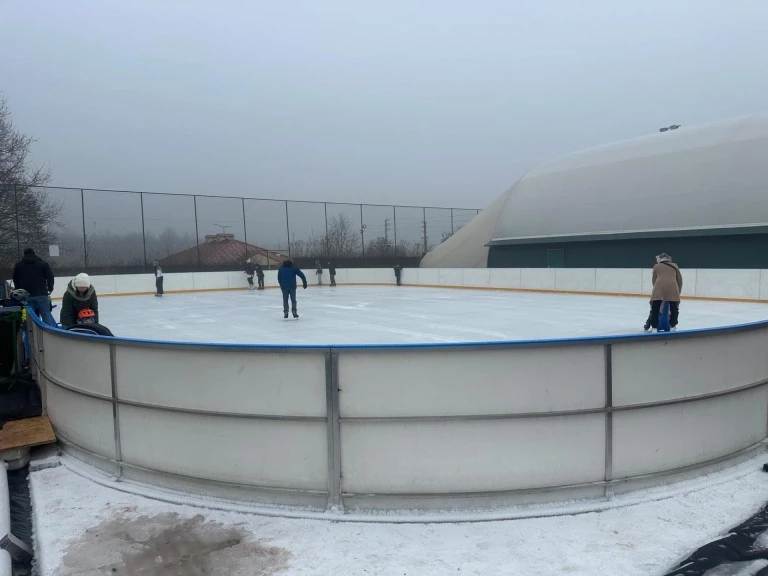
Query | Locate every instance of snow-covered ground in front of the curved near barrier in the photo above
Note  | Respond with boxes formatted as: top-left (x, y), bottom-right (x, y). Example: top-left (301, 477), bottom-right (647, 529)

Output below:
top-left (31, 456), bottom-right (768, 576)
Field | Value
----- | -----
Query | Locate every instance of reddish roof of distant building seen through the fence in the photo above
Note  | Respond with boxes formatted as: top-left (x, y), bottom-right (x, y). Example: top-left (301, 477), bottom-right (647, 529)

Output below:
top-left (160, 234), bottom-right (286, 267)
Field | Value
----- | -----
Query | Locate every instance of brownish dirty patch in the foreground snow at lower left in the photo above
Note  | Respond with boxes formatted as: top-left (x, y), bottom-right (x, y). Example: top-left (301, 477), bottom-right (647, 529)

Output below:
top-left (59, 514), bottom-right (290, 576)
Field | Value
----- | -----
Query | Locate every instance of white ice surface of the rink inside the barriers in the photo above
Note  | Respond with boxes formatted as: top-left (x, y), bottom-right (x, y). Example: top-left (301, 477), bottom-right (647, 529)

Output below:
top-left (67, 286), bottom-right (768, 344)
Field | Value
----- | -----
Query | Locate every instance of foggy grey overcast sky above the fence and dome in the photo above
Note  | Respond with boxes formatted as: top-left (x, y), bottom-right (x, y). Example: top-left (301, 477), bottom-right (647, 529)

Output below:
top-left (0, 0), bottom-right (768, 208)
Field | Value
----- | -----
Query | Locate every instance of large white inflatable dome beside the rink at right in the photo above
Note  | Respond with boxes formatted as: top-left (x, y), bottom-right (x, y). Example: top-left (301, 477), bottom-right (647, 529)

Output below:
top-left (421, 115), bottom-right (768, 268)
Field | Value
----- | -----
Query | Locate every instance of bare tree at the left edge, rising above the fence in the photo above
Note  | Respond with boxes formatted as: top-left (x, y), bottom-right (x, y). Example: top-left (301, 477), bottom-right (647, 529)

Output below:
top-left (0, 94), bottom-right (61, 267)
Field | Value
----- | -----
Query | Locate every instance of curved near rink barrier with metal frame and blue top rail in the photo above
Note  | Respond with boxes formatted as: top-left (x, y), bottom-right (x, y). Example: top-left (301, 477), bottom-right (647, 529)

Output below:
top-left (25, 294), bottom-right (768, 510)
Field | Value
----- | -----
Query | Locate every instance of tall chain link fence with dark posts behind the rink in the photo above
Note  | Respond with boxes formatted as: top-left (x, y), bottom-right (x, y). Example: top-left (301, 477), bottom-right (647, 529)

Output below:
top-left (0, 187), bottom-right (479, 277)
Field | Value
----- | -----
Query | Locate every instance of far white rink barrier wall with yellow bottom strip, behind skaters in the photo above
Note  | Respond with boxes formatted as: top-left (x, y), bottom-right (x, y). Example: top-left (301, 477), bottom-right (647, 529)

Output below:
top-left (51, 268), bottom-right (768, 302)
